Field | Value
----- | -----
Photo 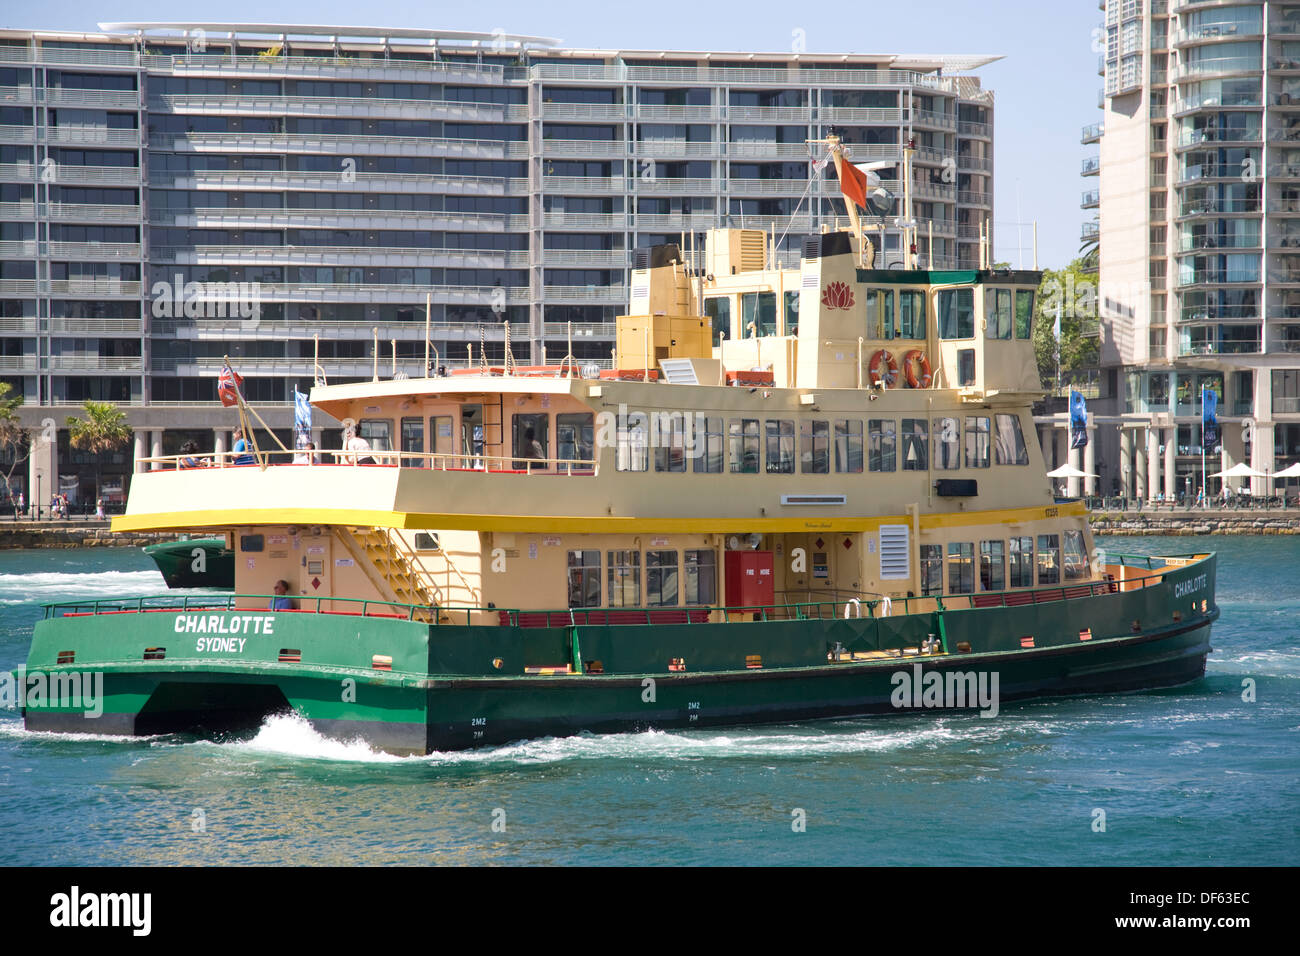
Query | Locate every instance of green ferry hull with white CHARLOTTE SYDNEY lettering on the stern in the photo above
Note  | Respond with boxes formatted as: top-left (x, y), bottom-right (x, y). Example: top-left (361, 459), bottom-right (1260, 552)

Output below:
top-left (17, 555), bottom-right (1218, 753)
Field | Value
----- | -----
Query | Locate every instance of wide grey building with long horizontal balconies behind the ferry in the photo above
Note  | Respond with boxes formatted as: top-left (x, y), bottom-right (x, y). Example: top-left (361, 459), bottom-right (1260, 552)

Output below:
top-left (0, 23), bottom-right (995, 501)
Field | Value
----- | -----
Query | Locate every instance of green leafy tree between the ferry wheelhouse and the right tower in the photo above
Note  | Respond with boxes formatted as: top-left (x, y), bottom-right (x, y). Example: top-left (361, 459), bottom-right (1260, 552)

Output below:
top-left (1034, 259), bottom-right (1101, 394)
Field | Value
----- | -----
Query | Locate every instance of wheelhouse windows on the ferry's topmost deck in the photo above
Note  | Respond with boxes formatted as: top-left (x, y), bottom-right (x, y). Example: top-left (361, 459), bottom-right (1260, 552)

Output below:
top-left (705, 289), bottom-right (1034, 345)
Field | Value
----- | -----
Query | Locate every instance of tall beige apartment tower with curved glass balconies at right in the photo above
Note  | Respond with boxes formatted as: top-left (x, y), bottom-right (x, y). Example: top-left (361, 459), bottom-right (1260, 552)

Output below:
top-left (1086, 0), bottom-right (1300, 497)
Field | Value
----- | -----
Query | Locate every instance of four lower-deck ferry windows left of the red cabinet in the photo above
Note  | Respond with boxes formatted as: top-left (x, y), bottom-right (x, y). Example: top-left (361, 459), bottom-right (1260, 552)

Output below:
top-left (568, 549), bottom-right (718, 607)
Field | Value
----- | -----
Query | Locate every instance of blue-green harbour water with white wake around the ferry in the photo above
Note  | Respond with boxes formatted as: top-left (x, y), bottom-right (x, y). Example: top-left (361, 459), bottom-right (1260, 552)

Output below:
top-left (0, 537), bottom-right (1300, 865)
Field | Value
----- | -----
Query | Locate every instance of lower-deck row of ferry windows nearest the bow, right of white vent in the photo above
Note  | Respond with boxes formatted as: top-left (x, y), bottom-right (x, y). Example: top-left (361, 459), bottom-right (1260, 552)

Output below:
top-left (920, 531), bottom-right (1088, 594)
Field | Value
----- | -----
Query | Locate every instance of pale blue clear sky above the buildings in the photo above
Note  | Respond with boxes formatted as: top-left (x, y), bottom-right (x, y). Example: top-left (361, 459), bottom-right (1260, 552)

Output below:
top-left (0, 0), bottom-right (1102, 268)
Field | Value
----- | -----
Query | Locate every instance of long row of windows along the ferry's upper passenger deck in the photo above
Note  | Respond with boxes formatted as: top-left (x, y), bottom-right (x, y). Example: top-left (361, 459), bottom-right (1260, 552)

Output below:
top-left (616, 414), bottom-right (1030, 475)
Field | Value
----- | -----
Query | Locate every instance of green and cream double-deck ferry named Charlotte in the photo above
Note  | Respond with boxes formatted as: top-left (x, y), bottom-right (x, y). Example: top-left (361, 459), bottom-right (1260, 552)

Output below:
top-left (15, 140), bottom-right (1219, 753)
